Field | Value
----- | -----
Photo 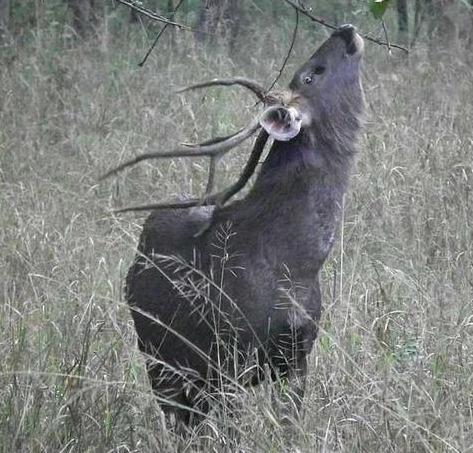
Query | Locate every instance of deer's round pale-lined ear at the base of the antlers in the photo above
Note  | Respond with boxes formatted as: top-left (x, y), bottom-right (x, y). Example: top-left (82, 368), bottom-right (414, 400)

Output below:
top-left (260, 106), bottom-right (302, 142)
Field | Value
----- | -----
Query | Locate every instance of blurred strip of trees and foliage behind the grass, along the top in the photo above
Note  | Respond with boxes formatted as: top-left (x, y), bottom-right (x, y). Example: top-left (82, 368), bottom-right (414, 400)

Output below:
top-left (0, 0), bottom-right (473, 52)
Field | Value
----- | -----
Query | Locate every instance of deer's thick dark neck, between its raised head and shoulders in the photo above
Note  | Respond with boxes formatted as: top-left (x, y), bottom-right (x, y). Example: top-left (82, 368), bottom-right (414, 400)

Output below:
top-left (214, 127), bottom-right (354, 281)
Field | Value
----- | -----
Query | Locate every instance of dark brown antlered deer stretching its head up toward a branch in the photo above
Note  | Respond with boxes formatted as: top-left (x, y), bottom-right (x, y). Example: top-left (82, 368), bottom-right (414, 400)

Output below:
top-left (113, 26), bottom-right (364, 423)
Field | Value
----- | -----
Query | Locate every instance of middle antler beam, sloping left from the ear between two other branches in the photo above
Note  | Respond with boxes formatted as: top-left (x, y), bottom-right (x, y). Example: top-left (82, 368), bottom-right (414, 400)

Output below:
top-left (99, 121), bottom-right (261, 181)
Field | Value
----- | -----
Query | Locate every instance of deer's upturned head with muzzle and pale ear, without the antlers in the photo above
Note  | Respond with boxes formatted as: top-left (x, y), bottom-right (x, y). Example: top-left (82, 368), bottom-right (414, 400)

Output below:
top-left (260, 25), bottom-right (364, 141)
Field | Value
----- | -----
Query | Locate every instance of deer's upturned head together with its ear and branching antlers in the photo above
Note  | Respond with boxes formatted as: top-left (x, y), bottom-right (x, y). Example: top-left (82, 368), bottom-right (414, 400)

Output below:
top-left (101, 25), bottom-right (364, 212)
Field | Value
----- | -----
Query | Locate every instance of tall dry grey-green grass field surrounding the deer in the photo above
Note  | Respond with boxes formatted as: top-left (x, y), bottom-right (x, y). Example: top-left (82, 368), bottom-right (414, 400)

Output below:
top-left (0, 1), bottom-right (473, 453)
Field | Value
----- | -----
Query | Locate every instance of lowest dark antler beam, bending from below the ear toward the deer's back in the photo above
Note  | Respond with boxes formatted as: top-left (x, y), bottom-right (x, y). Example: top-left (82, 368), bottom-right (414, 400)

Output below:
top-left (114, 129), bottom-right (269, 213)
